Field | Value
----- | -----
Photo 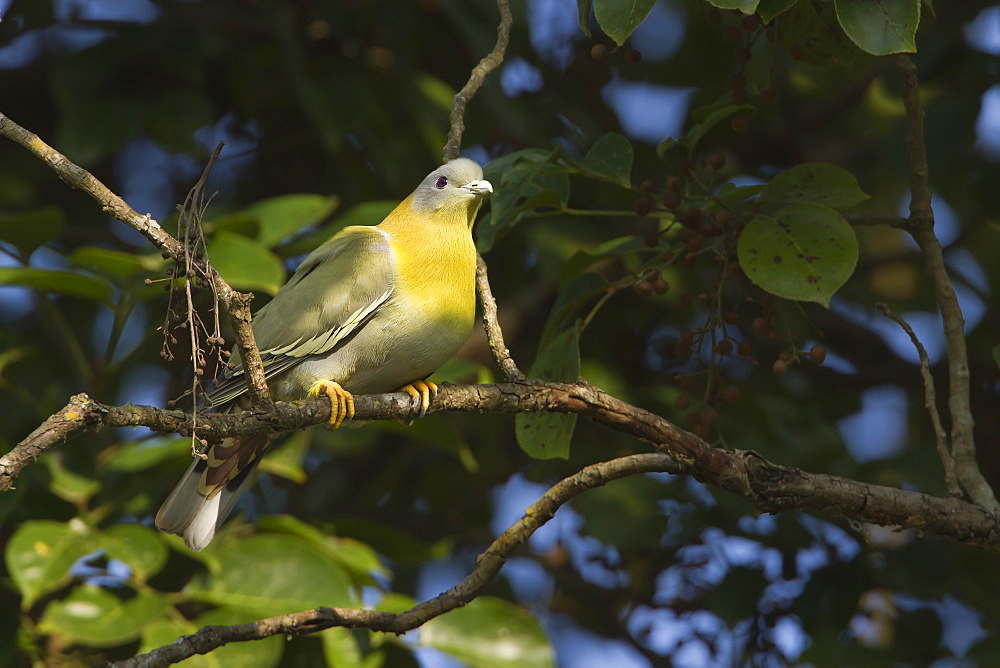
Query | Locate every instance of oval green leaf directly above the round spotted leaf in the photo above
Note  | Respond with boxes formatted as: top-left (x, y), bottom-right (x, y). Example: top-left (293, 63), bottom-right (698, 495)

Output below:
top-left (760, 162), bottom-right (868, 208)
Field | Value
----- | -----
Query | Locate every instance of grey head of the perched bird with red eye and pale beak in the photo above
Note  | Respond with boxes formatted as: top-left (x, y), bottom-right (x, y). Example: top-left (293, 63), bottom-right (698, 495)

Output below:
top-left (413, 158), bottom-right (493, 225)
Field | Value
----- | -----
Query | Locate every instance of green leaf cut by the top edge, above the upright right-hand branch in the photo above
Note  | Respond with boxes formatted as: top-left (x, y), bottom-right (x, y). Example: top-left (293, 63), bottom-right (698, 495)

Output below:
top-left (834, 0), bottom-right (920, 56)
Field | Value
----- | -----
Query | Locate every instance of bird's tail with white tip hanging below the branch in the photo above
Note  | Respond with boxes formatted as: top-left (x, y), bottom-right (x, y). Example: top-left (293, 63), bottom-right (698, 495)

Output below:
top-left (156, 435), bottom-right (271, 552)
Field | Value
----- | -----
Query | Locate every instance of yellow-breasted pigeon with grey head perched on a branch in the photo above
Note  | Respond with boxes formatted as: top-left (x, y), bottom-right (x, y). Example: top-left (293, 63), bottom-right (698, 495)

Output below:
top-left (155, 158), bottom-right (493, 551)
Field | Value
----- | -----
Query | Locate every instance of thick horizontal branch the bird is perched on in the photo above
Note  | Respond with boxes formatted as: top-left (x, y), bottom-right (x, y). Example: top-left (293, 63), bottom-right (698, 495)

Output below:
top-left (12, 379), bottom-right (1000, 552)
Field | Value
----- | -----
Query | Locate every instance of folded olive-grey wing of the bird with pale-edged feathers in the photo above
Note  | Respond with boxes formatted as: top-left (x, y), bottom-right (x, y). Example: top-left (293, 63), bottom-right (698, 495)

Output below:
top-left (207, 226), bottom-right (395, 408)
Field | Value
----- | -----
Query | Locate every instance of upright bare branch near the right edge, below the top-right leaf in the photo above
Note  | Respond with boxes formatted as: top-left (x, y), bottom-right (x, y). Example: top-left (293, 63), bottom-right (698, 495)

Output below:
top-left (894, 54), bottom-right (1000, 513)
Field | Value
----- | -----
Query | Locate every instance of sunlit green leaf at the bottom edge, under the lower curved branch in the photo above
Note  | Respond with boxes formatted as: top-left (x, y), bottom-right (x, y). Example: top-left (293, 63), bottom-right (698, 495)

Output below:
top-left (420, 596), bottom-right (555, 668)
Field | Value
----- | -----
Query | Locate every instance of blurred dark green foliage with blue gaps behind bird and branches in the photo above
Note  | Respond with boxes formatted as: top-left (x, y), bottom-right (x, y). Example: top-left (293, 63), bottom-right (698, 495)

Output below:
top-left (0, 0), bottom-right (1000, 665)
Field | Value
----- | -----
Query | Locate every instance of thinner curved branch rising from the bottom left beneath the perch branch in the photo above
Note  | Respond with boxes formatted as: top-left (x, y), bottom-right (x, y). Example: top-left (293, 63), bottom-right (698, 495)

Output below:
top-left (112, 453), bottom-right (679, 668)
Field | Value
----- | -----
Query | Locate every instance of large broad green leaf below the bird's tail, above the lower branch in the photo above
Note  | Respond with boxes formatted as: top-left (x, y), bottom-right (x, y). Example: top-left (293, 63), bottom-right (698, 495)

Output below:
top-left (193, 534), bottom-right (357, 617)
